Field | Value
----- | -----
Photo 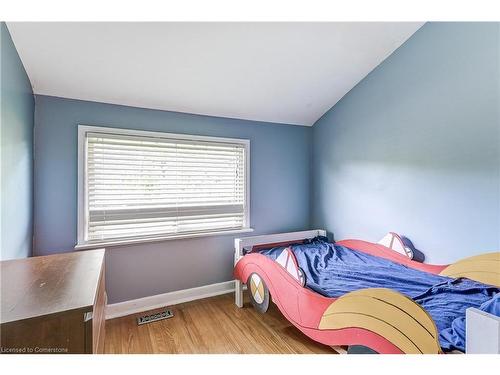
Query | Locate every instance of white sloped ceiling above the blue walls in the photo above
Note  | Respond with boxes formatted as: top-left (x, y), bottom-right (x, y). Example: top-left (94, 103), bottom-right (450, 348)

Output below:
top-left (8, 22), bottom-right (422, 126)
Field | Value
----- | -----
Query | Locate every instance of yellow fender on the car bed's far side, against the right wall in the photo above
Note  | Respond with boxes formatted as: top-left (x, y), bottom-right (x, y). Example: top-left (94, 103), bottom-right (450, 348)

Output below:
top-left (440, 252), bottom-right (500, 288)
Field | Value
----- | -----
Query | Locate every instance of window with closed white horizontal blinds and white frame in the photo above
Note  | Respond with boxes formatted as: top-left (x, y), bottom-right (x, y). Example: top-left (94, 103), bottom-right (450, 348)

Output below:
top-left (77, 126), bottom-right (250, 247)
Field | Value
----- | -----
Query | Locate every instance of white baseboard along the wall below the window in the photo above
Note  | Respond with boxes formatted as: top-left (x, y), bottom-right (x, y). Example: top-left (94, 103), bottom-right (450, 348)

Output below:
top-left (106, 280), bottom-right (234, 319)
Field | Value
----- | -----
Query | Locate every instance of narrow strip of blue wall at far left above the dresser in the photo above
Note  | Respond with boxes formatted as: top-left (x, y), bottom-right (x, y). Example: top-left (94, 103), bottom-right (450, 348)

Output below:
top-left (0, 22), bottom-right (34, 260)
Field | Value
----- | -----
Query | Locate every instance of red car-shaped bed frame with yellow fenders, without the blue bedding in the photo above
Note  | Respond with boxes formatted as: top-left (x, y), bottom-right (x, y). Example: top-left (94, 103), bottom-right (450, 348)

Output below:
top-left (234, 230), bottom-right (500, 354)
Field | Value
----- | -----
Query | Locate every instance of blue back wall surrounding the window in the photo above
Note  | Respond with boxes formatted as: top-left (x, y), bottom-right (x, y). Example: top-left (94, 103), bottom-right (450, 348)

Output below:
top-left (35, 95), bottom-right (311, 303)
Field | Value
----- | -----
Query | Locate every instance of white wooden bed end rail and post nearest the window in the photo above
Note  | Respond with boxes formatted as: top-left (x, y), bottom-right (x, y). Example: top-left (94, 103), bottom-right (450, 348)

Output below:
top-left (234, 229), bottom-right (326, 307)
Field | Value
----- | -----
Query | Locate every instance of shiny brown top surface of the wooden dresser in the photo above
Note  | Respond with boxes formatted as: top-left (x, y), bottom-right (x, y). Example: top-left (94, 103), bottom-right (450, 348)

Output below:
top-left (0, 249), bottom-right (104, 324)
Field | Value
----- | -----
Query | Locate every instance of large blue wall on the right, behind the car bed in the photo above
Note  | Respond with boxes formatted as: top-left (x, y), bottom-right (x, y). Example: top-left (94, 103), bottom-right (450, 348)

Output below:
top-left (311, 23), bottom-right (500, 263)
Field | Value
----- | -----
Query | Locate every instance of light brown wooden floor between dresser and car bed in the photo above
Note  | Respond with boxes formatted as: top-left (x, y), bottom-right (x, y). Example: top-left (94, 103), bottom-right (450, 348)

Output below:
top-left (105, 294), bottom-right (335, 354)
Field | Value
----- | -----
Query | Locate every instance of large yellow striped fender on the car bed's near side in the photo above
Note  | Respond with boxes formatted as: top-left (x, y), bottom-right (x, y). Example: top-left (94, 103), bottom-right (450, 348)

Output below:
top-left (319, 288), bottom-right (441, 354)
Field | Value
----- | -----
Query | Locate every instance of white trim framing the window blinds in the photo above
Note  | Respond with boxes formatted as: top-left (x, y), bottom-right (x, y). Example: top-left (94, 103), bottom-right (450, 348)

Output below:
top-left (75, 124), bottom-right (253, 250)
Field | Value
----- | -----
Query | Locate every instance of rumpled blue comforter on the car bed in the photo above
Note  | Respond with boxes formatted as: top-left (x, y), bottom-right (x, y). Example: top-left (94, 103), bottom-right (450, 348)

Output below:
top-left (261, 237), bottom-right (500, 351)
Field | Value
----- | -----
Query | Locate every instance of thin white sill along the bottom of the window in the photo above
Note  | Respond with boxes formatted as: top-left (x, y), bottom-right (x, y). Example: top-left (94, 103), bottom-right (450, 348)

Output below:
top-left (75, 228), bottom-right (253, 250)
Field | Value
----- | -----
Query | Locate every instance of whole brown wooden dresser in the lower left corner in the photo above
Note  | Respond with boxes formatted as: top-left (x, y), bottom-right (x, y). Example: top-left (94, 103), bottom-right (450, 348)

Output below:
top-left (0, 249), bottom-right (106, 353)
